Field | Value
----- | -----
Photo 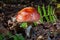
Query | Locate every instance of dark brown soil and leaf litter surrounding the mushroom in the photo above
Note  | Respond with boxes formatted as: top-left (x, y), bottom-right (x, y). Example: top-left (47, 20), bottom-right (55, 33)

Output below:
top-left (0, 0), bottom-right (60, 40)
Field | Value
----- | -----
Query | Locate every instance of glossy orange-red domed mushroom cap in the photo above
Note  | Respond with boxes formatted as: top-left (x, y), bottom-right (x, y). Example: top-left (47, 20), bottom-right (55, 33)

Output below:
top-left (16, 7), bottom-right (40, 22)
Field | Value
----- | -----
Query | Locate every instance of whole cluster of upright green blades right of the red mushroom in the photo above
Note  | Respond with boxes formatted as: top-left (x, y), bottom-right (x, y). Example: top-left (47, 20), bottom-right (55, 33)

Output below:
top-left (38, 4), bottom-right (57, 23)
